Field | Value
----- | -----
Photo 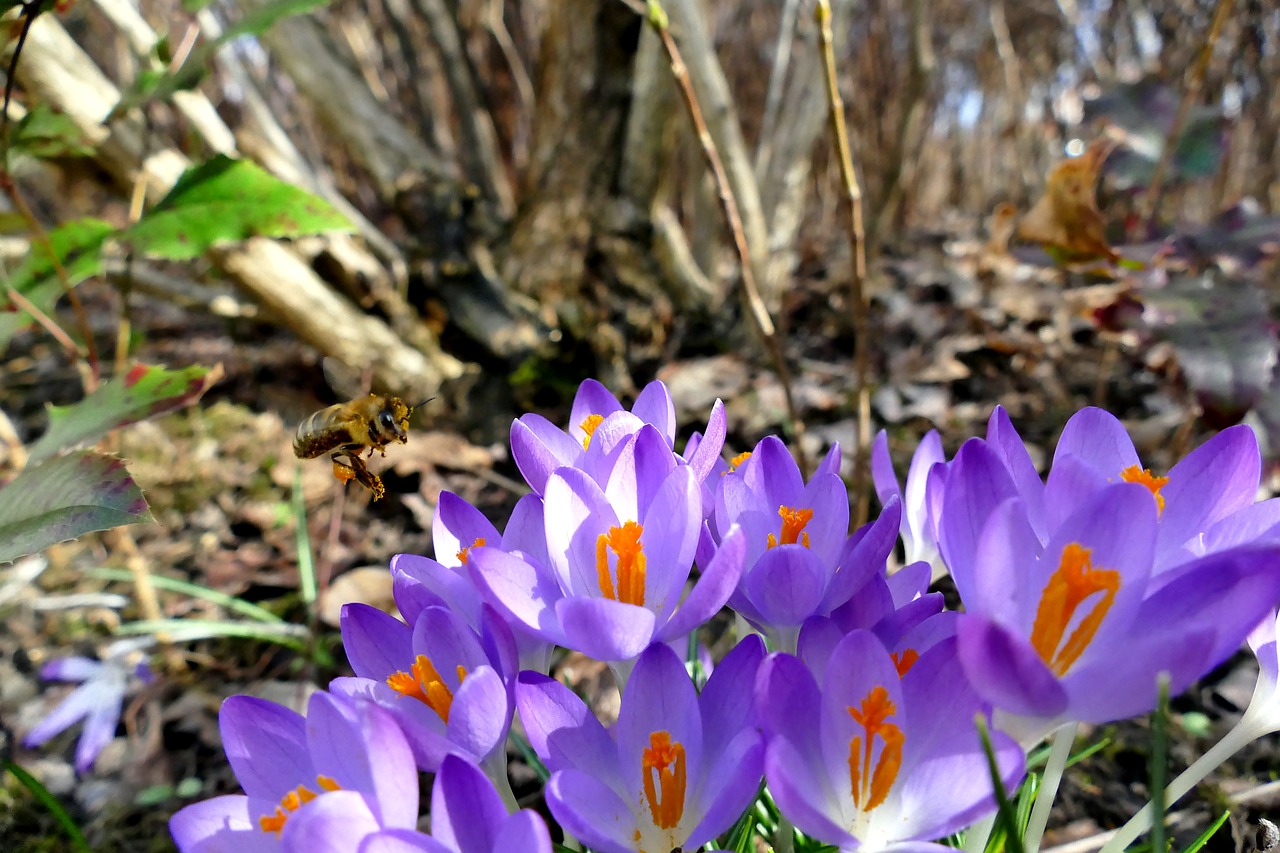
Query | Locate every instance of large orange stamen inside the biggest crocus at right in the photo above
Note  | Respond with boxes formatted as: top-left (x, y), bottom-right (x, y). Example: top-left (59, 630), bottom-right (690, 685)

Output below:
top-left (1030, 542), bottom-right (1120, 676)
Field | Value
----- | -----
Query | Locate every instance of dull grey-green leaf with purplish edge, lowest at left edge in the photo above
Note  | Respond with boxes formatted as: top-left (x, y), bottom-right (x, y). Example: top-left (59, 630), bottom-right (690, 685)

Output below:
top-left (0, 451), bottom-right (151, 562)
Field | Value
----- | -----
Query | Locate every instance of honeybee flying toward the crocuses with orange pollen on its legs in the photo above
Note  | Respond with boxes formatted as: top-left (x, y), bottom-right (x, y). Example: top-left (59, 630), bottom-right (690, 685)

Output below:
top-left (293, 359), bottom-right (434, 501)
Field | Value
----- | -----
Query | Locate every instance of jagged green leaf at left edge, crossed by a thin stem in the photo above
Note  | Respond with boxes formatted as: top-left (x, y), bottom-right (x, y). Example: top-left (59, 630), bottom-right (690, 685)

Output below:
top-left (0, 218), bottom-right (115, 350)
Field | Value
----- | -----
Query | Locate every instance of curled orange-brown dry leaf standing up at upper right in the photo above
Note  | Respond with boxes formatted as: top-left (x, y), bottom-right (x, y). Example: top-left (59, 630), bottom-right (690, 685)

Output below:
top-left (1018, 138), bottom-right (1120, 264)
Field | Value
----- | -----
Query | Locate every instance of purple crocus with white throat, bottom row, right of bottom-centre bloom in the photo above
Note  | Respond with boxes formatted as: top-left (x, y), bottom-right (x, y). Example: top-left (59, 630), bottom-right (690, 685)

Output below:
top-left (756, 631), bottom-right (1025, 853)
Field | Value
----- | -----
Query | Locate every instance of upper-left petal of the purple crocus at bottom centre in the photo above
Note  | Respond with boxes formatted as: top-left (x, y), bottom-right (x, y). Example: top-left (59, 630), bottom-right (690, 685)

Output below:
top-left (516, 672), bottom-right (617, 772)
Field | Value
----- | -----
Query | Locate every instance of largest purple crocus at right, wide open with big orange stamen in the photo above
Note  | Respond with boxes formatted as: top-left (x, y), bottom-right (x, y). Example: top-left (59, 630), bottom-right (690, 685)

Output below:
top-left (940, 432), bottom-right (1280, 745)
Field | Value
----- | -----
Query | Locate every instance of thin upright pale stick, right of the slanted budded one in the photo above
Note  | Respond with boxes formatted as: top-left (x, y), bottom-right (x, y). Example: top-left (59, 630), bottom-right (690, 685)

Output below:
top-left (815, 0), bottom-right (872, 526)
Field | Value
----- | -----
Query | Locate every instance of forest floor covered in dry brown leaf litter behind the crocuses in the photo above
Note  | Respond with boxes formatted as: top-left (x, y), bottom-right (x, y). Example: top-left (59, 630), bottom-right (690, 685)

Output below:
top-left (0, 224), bottom-right (1280, 853)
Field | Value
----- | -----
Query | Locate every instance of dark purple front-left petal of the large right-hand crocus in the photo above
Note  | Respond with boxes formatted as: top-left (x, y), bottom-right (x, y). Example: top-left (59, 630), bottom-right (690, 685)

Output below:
top-left (956, 613), bottom-right (1066, 717)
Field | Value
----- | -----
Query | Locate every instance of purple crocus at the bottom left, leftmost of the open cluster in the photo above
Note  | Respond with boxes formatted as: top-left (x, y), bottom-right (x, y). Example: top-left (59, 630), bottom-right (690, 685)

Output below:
top-left (169, 693), bottom-right (417, 853)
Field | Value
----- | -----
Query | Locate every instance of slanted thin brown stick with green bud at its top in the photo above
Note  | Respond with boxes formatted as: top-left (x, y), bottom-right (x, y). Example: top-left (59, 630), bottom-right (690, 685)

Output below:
top-left (622, 0), bottom-right (809, 474)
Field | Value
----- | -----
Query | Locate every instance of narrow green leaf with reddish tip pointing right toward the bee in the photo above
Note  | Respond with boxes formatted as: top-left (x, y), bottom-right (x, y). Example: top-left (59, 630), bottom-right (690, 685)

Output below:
top-left (31, 364), bottom-right (223, 462)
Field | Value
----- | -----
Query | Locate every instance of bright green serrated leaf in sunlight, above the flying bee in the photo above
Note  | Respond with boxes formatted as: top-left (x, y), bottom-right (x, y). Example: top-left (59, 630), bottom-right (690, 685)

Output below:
top-left (123, 155), bottom-right (351, 260)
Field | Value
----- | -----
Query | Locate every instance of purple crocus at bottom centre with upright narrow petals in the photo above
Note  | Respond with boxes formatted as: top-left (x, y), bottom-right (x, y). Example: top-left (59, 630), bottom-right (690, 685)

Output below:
top-left (516, 637), bottom-right (764, 853)
